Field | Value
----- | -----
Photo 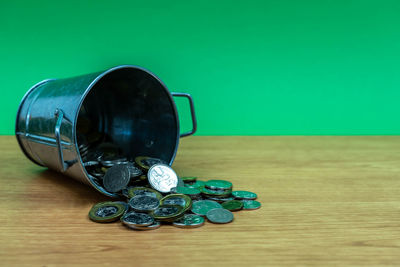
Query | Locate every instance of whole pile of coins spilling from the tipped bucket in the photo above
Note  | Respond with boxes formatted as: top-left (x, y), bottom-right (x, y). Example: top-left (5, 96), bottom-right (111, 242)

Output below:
top-left (84, 151), bottom-right (261, 231)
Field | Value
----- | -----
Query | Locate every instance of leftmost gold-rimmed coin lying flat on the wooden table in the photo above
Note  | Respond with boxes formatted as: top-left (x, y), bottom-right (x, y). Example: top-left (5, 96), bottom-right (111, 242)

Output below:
top-left (89, 201), bottom-right (125, 223)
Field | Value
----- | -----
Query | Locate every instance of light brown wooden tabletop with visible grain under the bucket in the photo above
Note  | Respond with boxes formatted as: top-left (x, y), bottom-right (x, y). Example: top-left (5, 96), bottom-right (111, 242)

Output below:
top-left (0, 136), bottom-right (400, 266)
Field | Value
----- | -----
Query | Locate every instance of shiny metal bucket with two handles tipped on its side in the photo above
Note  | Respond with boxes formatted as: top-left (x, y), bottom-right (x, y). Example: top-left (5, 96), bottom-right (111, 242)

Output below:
top-left (15, 65), bottom-right (196, 196)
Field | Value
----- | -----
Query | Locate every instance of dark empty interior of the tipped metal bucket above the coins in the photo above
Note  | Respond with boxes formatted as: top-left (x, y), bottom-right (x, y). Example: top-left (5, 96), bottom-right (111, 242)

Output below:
top-left (76, 67), bottom-right (179, 194)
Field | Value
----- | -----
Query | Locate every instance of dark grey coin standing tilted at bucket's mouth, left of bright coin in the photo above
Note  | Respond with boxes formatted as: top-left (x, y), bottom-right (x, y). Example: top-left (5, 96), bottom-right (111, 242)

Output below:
top-left (103, 165), bottom-right (130, 193)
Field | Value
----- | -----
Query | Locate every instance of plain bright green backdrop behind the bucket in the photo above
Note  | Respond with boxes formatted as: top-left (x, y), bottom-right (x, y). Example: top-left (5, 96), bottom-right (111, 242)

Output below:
top-left (0, 0), bottom-right (400, 135)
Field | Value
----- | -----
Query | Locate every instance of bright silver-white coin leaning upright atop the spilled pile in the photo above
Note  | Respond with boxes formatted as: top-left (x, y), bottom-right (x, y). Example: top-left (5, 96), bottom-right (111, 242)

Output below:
top-left (147, 164), bottom-right (178, 193)
